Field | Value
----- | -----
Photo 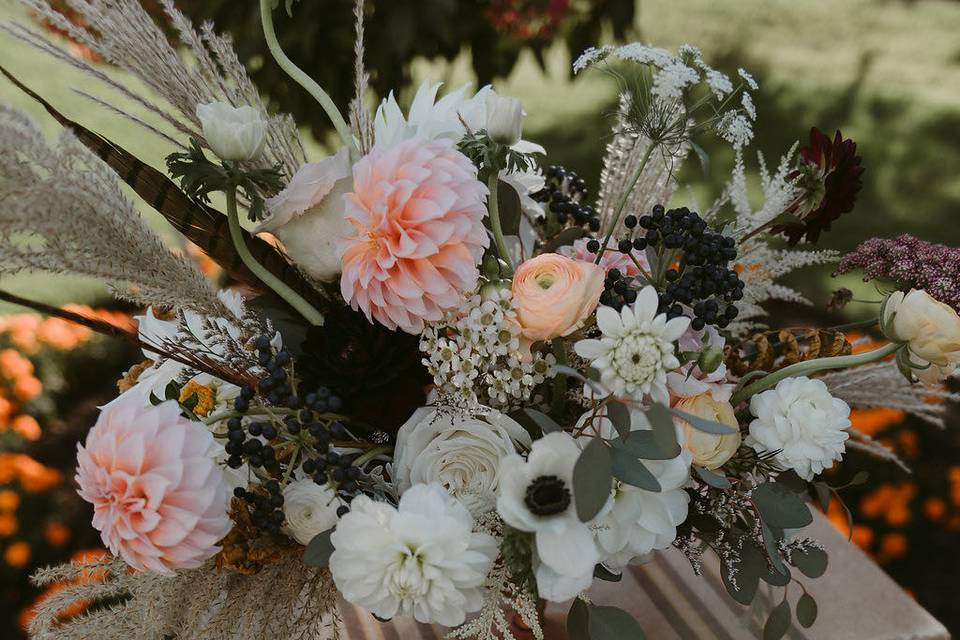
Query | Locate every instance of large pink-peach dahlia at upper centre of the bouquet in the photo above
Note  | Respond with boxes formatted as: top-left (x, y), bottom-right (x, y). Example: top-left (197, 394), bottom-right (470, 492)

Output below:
top-left (337, 138), bottom-right (490, 333)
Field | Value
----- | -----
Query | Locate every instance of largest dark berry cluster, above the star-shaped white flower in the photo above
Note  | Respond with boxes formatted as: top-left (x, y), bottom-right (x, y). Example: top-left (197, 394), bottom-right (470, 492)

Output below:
top-left (640, 205), bottom-right (744, 330)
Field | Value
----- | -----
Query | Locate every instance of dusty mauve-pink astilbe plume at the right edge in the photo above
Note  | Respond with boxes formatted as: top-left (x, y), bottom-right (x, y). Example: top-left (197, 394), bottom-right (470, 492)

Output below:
top-left (834, 233), bottom-right (960, 313)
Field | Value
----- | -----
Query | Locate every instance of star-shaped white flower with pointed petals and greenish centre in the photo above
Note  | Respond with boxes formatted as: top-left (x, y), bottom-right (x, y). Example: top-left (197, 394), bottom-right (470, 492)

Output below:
top-left (574, 286), bottom-right (690, 403)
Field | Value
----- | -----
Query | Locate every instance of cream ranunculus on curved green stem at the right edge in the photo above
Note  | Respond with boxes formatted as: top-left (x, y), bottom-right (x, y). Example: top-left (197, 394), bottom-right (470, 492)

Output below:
top-left (881, 289), bottom-right (960, 378)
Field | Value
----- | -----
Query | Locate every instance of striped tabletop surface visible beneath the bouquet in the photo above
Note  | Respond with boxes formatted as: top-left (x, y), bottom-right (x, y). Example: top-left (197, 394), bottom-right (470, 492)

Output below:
top-left (341, 513), bottom-right (950, 640)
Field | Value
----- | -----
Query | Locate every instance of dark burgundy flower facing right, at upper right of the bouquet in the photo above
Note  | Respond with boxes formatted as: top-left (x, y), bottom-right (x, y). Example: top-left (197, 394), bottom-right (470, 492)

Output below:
top-left (772, 127), bottom-right (865, 245)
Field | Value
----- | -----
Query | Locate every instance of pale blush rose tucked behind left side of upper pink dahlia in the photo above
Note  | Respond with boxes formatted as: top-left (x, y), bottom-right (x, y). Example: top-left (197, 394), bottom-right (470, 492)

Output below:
top-left (256, 147), bottom-right (353, 282)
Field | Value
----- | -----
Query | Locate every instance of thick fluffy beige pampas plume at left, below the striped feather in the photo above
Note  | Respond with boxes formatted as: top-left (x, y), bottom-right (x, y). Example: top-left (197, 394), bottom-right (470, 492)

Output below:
top-left (0, 107), bottom-right (227, 315)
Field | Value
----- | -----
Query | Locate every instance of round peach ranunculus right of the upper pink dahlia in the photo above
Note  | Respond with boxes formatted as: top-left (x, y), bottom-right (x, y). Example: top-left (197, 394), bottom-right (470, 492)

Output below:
top-left (513, 253), bottom-right (605, 347)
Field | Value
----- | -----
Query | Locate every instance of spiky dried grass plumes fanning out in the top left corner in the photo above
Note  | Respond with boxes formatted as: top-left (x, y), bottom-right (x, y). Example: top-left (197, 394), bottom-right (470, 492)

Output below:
top-left (0, 0), bottom-right (306, 176)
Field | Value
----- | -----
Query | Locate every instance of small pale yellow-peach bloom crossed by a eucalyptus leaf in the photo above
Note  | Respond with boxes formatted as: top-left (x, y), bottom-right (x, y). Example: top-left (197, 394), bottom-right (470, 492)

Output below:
top-left (674, 391), bottom-right (741, 469)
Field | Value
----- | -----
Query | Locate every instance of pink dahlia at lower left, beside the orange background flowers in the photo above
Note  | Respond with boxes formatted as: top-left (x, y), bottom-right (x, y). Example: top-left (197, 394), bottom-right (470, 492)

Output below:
top-left (76, 397), bottom-right (231, 575)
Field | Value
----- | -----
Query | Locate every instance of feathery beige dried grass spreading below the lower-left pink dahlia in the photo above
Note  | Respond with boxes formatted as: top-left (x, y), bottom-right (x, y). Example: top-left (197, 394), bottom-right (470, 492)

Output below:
top-left (29, 554), bottom-right (340, 640)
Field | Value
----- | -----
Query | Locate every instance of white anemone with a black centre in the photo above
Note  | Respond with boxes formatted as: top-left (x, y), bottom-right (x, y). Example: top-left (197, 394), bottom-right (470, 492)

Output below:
top-left (497, 431), bottom-right (600, 599)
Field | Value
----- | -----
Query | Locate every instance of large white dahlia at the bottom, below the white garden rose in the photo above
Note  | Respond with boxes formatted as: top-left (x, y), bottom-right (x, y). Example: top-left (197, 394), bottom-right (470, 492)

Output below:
top-left (330, 484), bottom-right (497, 627)
